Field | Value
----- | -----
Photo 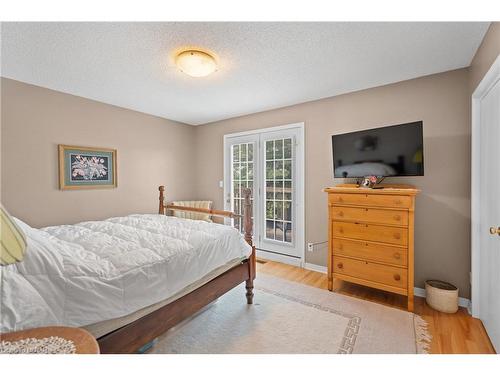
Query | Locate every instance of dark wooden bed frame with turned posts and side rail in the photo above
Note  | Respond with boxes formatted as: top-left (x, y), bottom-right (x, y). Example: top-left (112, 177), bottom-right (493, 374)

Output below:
top-left (97, 186), bottom-right (255, 353)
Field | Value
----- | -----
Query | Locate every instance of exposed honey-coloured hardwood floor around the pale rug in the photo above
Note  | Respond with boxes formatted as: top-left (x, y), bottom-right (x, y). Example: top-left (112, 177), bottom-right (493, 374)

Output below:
top-left (257, 260), bottom-right (495, 354)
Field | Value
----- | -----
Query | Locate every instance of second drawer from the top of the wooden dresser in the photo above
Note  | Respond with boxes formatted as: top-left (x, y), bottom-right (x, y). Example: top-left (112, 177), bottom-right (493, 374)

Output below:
top-left (330, 206), bottom-right (408, 226)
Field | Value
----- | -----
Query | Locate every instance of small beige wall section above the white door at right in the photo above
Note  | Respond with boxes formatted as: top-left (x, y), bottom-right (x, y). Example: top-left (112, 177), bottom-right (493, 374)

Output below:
top-left (469, 22), bottom-right (500, 93)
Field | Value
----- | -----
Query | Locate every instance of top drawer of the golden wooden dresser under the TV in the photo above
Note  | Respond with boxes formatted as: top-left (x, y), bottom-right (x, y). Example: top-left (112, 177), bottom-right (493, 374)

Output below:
top-left (328, 193), bottom-right (412, 208)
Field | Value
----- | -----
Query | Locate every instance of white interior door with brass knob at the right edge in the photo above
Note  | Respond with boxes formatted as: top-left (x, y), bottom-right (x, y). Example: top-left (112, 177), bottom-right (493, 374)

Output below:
top-left (479, 77), bottom-right (500, 352)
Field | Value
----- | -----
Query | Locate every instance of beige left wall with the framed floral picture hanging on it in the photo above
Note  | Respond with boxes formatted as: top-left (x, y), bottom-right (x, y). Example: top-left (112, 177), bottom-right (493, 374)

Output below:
top-left (1, 79), bottom-right (195, 227)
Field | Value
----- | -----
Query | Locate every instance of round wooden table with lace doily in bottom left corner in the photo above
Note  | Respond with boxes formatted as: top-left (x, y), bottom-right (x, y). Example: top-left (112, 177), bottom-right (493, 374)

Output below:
top-left (0, 327), bottom-right (99, 354)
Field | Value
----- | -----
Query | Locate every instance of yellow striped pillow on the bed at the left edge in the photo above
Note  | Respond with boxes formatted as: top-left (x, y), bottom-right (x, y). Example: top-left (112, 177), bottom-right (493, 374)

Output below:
top-left (0, 204), bottom-right (26, 266)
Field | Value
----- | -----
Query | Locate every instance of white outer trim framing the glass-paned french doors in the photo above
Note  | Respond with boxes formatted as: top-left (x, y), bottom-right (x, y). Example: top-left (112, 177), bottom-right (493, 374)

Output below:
top-left (223, 122), bottom-right (306, 267)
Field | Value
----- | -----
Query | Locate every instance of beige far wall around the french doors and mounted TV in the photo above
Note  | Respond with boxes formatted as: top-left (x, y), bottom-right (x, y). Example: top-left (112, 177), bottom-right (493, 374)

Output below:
top-left (196, 69), bottom-right (470, 296)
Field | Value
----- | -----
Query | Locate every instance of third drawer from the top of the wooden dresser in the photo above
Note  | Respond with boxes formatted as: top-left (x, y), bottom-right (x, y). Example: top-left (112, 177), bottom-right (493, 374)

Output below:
top-left (332, 221), bottom-right (408, 246)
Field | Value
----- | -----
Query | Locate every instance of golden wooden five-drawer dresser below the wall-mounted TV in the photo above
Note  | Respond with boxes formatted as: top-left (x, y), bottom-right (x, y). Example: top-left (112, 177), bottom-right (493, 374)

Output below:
top-left (324, 184), bottom-right (419, 311)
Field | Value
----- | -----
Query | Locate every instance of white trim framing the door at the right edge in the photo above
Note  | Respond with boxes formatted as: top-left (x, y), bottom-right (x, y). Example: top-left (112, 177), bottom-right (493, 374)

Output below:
top-left (471, 55), bottom-right (500, 318)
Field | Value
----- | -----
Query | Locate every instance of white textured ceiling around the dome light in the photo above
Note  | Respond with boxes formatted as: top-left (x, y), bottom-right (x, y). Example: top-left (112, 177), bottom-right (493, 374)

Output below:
top-left (1, 22), bottom-right (489, 125)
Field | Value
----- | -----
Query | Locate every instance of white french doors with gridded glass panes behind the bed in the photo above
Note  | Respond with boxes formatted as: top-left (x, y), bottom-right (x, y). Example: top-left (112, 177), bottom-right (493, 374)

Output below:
top-left (224, 124), bottom-right (304, 264)
